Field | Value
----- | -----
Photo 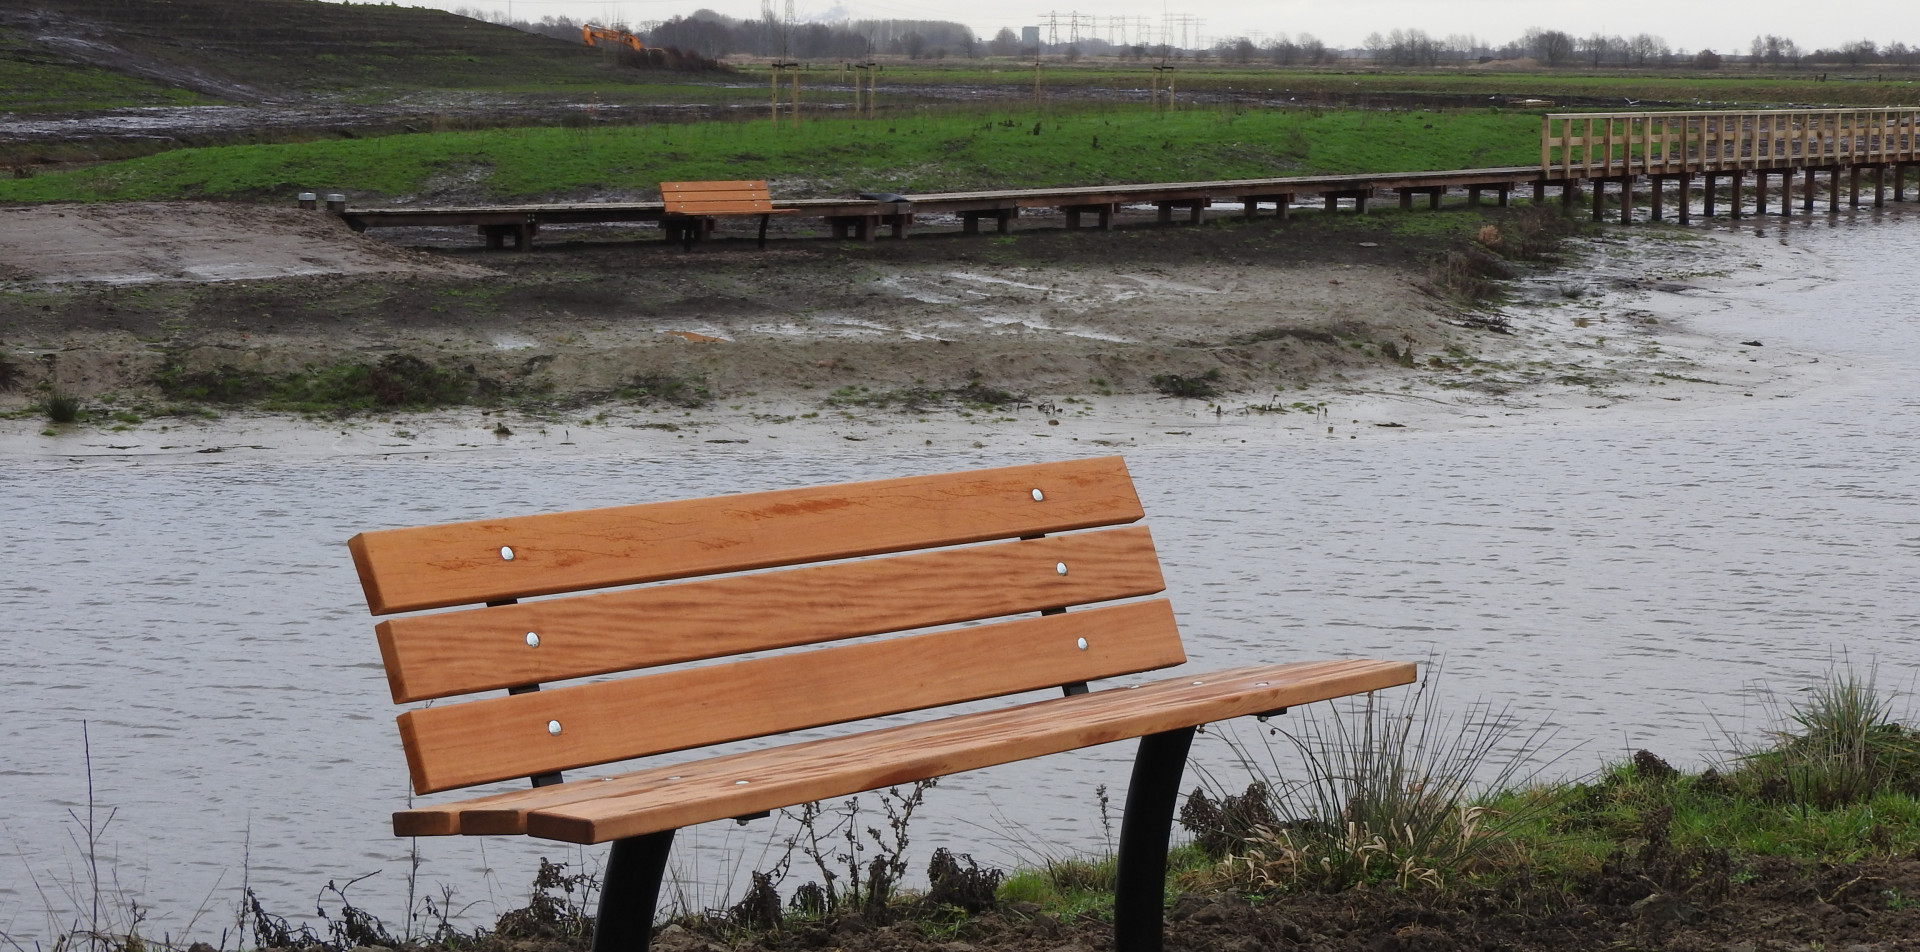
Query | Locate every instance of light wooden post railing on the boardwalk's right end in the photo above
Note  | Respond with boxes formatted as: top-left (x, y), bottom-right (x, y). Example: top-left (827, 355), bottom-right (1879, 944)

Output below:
top-left (1540, 107), bottom-right (1920, 179)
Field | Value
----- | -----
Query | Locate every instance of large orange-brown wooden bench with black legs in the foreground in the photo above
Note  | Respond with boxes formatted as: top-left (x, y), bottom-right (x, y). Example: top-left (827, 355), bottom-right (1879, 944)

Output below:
top-left (349, 457), bottom-right (1415, 952)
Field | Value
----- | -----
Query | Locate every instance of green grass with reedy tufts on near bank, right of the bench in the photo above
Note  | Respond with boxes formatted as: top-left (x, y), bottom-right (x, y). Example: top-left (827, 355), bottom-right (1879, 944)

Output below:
top-left (1181, 670), bottom-right (1920, 891)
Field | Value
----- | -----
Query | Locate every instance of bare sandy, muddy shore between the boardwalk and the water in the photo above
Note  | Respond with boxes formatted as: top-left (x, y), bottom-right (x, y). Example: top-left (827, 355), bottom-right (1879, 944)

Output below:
top-left (0, 205), bottom-right (1843, 455)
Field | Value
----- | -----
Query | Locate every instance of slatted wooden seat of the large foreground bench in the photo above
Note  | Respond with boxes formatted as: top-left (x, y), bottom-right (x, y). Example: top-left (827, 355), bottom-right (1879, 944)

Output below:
top-left (394, 660), bottom-right (1415, 843)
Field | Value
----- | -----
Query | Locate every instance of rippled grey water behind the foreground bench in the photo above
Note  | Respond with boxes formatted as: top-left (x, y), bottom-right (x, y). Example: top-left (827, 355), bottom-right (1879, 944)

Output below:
top-left (0, 215), bottom-right (1920, 939)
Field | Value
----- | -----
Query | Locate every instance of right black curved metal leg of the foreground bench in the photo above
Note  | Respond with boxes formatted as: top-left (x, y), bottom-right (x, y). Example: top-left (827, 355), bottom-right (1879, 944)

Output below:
top-left (1114, 727), bottom-right (1194, 952)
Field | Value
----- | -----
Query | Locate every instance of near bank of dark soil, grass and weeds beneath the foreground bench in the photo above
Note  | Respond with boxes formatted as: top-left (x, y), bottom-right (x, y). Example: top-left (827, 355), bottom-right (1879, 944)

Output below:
top-left (30, 670), bottom-right (1920, 952)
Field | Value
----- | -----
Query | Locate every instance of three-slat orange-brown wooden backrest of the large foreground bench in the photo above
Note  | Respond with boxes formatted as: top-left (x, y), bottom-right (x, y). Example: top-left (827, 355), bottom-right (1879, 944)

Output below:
top-left (349, 457), bottom-right (1187, 793)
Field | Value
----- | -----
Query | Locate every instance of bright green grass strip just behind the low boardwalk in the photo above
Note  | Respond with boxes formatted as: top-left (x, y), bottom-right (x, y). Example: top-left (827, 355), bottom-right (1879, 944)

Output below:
top-left (0, 107), bottom-right (1538, 202)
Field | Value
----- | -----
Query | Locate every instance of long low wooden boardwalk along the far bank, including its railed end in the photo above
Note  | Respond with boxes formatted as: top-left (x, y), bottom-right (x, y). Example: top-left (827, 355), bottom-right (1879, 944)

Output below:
top-left (328, 109), bottom-right (1920, 250)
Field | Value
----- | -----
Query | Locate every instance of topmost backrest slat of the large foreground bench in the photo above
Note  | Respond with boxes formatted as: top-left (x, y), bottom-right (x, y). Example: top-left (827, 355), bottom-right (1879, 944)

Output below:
top-left (348, 457), bottom-right (1144, 614)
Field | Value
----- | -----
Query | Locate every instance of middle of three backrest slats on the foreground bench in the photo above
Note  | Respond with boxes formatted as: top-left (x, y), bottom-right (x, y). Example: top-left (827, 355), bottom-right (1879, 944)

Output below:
top-left (376, 526), bottom-right (1165, 702)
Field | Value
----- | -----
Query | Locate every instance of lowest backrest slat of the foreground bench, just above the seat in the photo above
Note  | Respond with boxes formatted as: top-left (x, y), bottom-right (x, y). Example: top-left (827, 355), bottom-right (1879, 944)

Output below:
top-left (399, 599), bottom-right (1187, 793)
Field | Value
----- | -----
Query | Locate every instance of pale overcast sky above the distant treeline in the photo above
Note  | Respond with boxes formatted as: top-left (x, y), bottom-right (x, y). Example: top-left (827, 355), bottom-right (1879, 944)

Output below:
top-left (428, 0), bottom-right (1920, 52)
